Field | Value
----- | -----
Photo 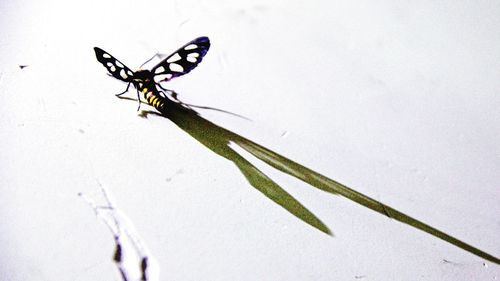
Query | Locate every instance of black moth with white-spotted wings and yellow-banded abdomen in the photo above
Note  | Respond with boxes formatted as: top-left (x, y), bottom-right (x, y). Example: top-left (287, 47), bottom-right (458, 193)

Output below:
top-left (94, 36), bottom-right (210, 107)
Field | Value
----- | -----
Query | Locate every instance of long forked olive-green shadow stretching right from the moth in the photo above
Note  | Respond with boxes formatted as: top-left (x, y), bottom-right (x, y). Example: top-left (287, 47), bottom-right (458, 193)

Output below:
top-left (140, 100), bottom-right (500, 264)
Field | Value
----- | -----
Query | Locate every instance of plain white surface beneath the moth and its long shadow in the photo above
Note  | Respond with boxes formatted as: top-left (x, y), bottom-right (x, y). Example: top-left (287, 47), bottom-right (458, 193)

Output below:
top-left (0, 0), bottom-right (500, 280)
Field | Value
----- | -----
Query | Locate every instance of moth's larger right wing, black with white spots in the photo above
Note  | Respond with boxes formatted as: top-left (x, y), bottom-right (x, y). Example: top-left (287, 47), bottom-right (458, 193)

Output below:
top-left (151, 37), bottom-right (210, 83)
